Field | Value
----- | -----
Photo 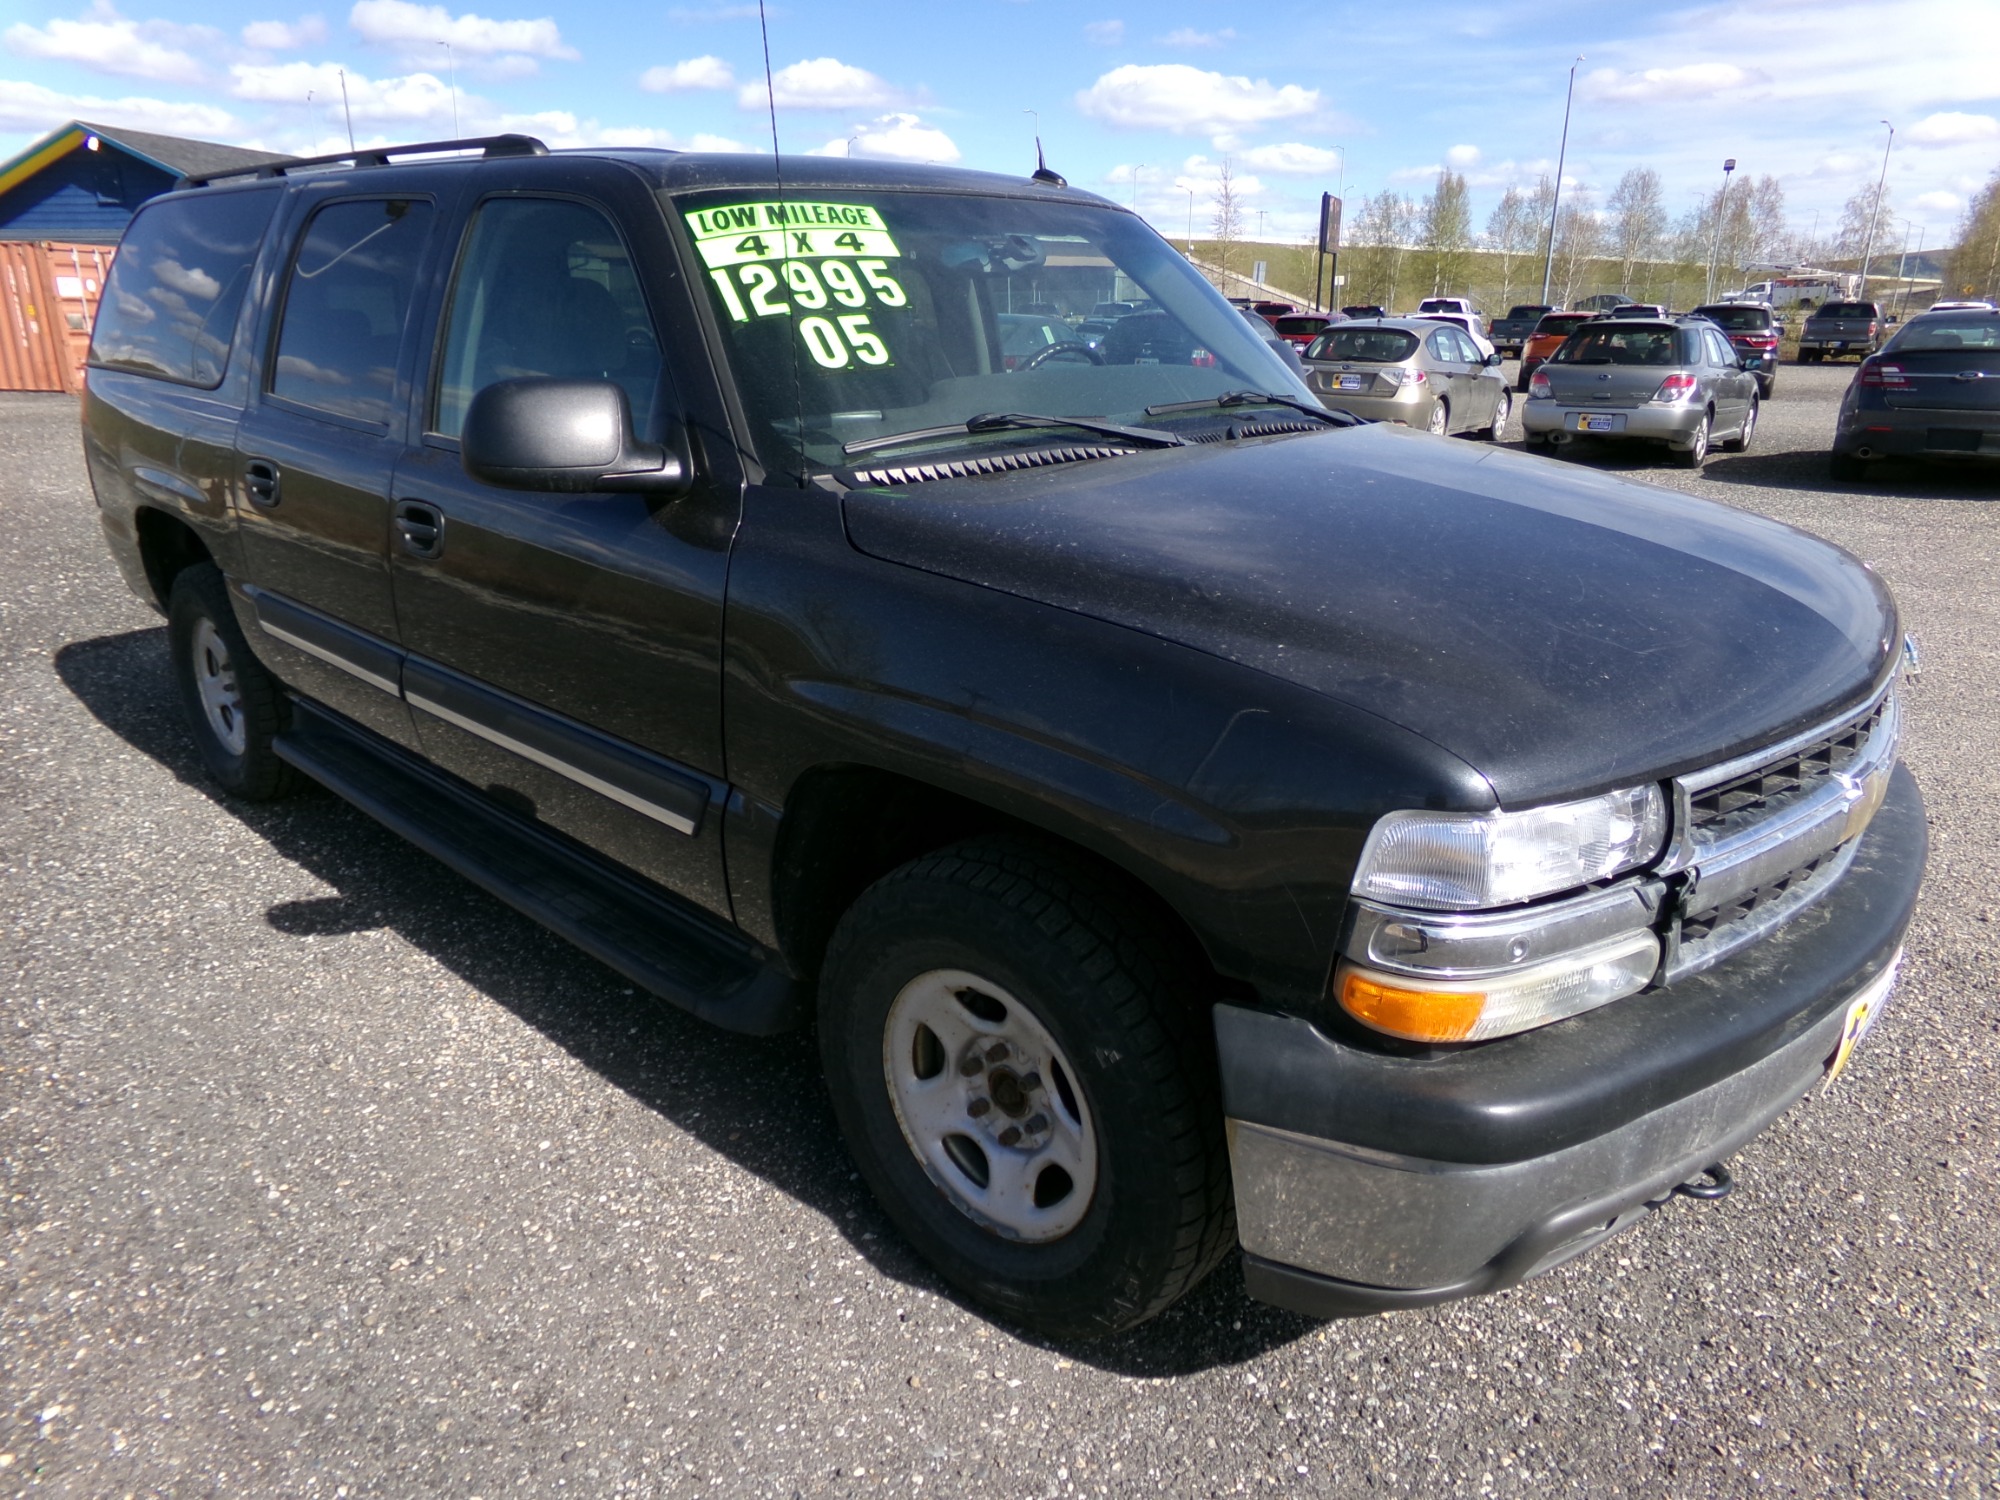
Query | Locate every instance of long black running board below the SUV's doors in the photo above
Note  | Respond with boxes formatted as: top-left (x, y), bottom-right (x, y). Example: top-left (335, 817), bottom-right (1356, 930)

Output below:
top-left (272, 698), bottom-right (806, 1036)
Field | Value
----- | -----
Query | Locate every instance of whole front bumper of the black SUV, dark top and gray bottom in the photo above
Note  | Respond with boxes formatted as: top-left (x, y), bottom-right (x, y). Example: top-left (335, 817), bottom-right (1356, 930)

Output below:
top-left (1216, 768), bottom-right (1926, 1316)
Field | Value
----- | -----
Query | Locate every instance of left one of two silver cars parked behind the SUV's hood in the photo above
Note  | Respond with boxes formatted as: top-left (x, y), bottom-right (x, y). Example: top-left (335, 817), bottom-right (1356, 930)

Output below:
top-left (1306, 318), bottom-right (1514, 440)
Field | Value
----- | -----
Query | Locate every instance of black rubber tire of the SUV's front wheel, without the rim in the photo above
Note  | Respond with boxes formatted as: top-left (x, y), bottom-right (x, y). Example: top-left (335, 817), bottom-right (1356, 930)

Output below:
top-left (818, 838), bottom-right (1236, 1338)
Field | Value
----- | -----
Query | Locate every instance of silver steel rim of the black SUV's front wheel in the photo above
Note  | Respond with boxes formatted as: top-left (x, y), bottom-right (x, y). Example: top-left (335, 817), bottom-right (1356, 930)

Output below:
top-left (882, 968), bottom-right (1098, 1244)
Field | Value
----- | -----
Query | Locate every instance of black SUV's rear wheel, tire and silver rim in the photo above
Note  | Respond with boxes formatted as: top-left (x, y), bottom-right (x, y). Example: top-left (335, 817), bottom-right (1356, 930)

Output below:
top-left (166, 562), bottom-right (298, 802)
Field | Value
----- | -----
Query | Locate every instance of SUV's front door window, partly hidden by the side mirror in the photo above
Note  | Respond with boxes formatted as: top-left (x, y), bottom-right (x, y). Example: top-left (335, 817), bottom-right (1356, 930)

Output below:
top-left (430, 198), bottom-right (660, 442)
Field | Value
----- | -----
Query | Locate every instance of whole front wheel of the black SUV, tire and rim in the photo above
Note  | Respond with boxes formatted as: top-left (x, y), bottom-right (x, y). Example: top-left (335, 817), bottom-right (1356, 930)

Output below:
top-left (820, 838), bottom-right (1234, 1338)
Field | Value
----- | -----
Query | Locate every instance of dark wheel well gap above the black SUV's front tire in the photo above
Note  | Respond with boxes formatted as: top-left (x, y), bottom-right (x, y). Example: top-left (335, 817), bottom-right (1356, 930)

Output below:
top-left (772, 766), bottom-right (1220, 1000)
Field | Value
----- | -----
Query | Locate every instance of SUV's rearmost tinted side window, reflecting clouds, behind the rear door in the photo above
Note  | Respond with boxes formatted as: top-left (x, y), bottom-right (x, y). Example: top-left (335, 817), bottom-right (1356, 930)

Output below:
top-left (90, 188), bottom-right (278, 386)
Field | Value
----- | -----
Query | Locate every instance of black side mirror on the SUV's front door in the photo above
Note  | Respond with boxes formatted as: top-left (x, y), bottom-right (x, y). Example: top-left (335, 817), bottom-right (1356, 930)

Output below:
top-left (458, 376), bottom-right (692, 494)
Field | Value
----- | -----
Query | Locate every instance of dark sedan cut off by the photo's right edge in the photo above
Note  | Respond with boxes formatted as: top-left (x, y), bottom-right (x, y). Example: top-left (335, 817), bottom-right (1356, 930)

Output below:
top-left (1830, 308), bottom-right (2000, 480)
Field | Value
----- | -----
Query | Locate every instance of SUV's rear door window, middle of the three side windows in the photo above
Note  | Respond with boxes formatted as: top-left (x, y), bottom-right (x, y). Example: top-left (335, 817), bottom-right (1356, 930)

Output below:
top-left (270, 198), bottom-right (430, 424)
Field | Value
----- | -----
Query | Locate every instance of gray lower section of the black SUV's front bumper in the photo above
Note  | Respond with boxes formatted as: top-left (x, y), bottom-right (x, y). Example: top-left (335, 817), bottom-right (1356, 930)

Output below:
top-left (1230, 972), bottom-right (1892, 1314)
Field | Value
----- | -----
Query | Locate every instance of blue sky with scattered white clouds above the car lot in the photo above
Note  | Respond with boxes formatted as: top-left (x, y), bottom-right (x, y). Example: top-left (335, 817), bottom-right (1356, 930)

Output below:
top-left (0, 0), bottom-right (2000, 246)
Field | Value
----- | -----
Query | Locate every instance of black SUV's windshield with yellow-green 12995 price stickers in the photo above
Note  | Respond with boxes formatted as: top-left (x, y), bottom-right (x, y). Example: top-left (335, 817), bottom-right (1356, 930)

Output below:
top-left (672, 190), bottom-right (1312, 474)
